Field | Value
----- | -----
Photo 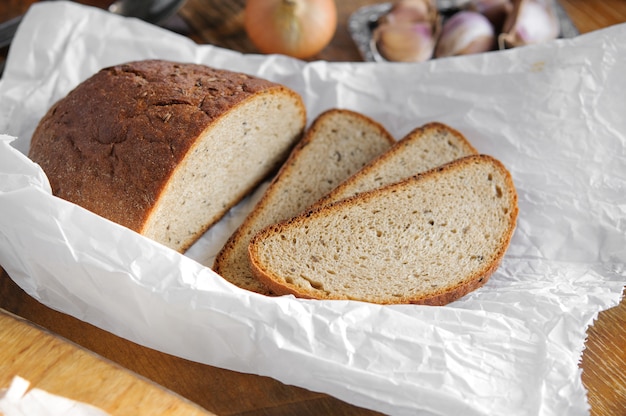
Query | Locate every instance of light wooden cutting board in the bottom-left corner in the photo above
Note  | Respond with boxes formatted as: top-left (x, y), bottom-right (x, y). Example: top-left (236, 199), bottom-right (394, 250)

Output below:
top-left (0, 309), bottom-right (213, 416)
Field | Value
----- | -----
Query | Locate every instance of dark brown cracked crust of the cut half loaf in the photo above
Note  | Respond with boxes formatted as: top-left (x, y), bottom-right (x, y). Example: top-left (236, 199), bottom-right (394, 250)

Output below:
top-left (29, 60), bottom-right (295, 232)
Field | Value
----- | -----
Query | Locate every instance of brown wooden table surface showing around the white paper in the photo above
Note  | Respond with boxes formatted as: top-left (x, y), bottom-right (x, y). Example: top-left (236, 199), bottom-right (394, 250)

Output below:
top-left (0, 0), bottom-right (626, 416)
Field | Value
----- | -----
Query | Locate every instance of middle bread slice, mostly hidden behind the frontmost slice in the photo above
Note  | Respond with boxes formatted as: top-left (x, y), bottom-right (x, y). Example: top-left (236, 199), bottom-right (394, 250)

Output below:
top-left (313, 122), bottom-right (478, 207)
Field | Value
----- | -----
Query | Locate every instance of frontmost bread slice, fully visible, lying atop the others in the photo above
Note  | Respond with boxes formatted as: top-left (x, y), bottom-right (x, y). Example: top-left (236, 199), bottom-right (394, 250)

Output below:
top-left (249, 155), bottom-right (518, 305)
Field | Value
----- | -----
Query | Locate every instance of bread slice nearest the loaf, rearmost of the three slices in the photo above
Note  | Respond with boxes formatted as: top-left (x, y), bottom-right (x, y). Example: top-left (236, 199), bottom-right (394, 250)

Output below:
top-left (213, 109), bottom-right (395, 294)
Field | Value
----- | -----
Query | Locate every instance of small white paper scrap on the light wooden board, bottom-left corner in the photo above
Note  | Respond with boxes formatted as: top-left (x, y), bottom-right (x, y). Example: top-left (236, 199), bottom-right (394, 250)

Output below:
top-left (0, 376), bottom-right (108, 416)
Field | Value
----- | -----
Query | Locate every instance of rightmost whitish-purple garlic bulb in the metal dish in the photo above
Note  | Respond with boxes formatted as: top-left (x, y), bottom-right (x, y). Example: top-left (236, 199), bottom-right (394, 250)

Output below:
top-left (499, 0), bottom-right (559, 48)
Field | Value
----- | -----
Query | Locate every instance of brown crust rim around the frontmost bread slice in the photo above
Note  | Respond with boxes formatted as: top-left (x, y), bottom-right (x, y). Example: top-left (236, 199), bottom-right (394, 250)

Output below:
top-left (248, 155), bottom-right (519, 306)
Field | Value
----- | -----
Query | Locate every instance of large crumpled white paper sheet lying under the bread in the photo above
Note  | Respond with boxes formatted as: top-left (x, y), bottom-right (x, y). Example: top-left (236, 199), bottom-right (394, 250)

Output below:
top-left (0, 2), bottom-right (626, 416)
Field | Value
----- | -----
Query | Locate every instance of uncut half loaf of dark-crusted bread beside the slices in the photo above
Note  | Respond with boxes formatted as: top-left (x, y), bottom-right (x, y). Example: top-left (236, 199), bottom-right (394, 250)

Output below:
top-left (29, 60), bottom-right (306, 252)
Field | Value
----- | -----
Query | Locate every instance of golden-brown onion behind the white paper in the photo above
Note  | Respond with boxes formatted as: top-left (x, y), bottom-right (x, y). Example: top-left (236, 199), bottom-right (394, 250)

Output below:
top-left (244, 0), bottom-right (337, 59)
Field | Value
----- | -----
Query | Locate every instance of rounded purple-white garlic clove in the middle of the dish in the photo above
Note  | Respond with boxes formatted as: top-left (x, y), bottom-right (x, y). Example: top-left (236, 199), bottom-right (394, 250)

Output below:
top-left (435, 10), bottom-right (496, 58)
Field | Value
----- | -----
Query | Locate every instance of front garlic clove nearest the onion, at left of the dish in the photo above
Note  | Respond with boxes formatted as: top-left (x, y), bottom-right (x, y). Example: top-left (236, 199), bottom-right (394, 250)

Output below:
top-left (372, 22), bottom-right (436, 62)
